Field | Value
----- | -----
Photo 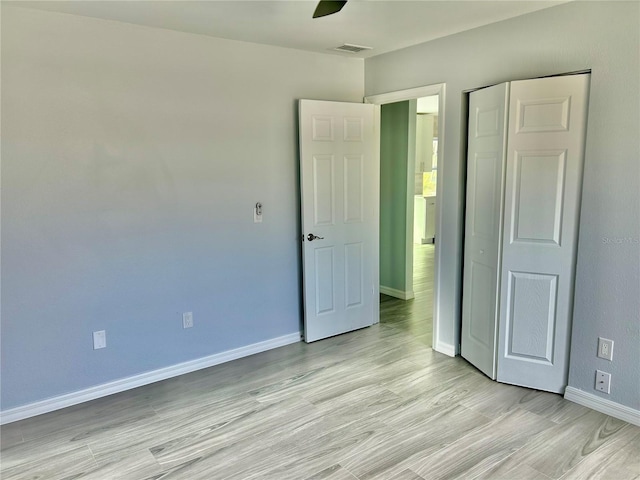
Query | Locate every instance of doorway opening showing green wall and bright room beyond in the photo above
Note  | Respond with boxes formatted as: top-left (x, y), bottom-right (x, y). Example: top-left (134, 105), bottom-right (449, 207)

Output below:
top-left (365, 84), bottom-right (444, 355)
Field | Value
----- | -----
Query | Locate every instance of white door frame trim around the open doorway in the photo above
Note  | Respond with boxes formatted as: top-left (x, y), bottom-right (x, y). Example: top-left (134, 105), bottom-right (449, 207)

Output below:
top-left (364, 83), bottom-right (456, 357)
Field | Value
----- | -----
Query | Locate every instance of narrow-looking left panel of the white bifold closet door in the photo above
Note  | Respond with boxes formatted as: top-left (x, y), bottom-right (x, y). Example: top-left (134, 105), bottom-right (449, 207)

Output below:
top-left (461, 83), bottom-right (509, 380)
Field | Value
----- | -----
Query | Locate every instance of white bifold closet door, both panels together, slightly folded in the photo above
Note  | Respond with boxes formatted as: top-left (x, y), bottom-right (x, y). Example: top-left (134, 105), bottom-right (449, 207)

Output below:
top-left (462, 74), bottom-right (589, 393)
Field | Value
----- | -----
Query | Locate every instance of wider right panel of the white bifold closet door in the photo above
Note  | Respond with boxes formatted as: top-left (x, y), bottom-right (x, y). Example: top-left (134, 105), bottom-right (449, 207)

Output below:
top-left (498, 75), bottom-right (589, 393)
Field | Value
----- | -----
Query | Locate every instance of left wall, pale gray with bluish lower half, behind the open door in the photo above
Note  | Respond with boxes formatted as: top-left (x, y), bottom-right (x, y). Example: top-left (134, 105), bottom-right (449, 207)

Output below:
top-left (1, 5), bottom-right (364, 409)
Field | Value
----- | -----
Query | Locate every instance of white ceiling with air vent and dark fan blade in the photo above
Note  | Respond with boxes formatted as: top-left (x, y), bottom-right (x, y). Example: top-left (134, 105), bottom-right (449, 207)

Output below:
top-left (13, 0), bottom-right (567, 58)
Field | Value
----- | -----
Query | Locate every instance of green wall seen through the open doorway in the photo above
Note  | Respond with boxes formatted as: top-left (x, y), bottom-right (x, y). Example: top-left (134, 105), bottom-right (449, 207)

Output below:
top-left (380, 101), bottom-right (416, 292)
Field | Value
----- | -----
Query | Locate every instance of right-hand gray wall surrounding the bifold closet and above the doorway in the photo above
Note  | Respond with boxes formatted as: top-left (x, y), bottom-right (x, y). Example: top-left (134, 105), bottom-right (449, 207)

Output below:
top-left (365, 1), bottom-right (640, 409)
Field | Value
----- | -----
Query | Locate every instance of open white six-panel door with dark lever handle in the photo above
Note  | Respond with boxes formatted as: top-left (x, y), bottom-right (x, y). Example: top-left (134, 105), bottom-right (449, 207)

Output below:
top-left (299, 100), bottom-right (379, 342)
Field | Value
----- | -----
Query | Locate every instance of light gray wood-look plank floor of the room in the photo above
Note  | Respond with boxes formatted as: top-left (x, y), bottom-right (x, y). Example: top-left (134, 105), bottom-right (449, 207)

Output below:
top-left (0, 248), bottom-right (640, 480)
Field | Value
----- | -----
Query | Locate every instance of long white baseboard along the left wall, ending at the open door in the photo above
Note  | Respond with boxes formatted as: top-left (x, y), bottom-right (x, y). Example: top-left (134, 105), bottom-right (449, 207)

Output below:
top-left (0, 332), bottom-right (301, 425)
